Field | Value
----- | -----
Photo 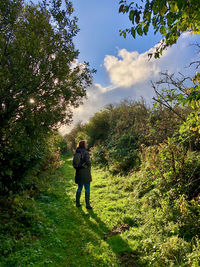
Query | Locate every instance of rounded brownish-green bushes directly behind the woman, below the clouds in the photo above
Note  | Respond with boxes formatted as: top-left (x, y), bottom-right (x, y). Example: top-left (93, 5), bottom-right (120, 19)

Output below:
top-left (66, 99), bottom-right (187, 173)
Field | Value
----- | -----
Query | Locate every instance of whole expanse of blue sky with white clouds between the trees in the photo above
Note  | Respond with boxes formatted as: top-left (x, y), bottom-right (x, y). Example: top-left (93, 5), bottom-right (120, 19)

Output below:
top-left (29, 0), bottom-right (200, 134)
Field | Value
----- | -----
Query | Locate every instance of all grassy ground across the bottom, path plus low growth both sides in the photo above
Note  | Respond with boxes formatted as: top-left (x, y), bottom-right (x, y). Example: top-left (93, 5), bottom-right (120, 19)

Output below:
top-left (0, 158), bottom-right (200, 267)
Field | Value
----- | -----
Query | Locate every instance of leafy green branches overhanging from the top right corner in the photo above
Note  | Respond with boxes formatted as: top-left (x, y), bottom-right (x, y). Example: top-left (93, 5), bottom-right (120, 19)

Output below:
top-left (119, 0), bottom-right (200, 140)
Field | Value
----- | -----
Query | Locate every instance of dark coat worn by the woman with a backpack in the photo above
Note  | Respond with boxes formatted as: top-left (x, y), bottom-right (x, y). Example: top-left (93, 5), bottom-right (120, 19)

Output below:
top-left (73, 148), bottom-right (92, 184)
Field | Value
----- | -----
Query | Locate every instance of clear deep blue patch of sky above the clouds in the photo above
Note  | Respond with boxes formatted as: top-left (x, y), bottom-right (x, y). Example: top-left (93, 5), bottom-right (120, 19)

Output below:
top-left (72, 0), bottom-right (160, 85)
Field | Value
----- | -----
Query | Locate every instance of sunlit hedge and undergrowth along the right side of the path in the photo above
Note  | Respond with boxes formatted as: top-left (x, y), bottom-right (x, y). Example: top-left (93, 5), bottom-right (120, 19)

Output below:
top-left (65, 56), bottom-right (200, 266)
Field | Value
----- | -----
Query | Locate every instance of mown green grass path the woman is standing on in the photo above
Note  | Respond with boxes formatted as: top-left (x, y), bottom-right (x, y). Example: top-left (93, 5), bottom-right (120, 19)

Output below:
top-left (0, 158), bottom-right (141, 267)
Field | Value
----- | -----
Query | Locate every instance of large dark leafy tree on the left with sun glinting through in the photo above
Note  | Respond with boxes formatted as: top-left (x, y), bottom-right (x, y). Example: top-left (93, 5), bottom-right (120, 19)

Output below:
top-left (0, 0), bottom-right (92, 194)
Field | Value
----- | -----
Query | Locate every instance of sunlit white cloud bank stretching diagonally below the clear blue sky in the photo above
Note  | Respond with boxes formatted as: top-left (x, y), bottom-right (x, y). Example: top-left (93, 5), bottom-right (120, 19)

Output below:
top-left (61, 34), bottom-right (200, 134)
